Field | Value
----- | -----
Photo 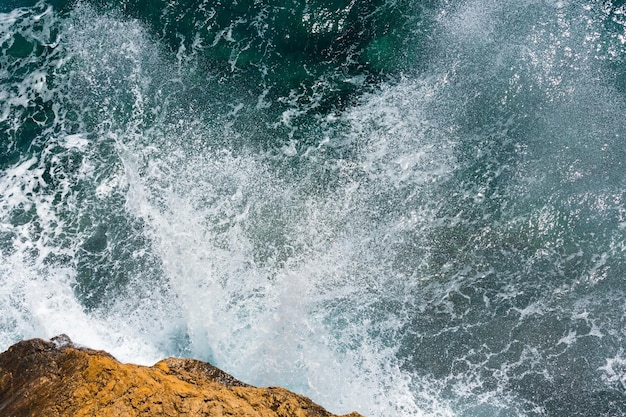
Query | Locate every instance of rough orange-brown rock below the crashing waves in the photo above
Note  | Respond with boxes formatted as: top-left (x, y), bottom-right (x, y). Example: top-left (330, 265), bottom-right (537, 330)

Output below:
top-left (0, 335), bottom-right (359, 417)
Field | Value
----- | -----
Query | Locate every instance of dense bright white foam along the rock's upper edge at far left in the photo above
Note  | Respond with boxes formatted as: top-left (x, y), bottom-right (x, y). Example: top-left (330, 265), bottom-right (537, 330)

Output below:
top-left (0, 252), bottom-right (165, 365)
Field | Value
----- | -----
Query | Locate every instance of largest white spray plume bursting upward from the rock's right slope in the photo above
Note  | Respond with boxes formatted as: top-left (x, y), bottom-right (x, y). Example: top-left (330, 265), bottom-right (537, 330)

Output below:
top-left (116, 135), bottom-right (434, 415)
